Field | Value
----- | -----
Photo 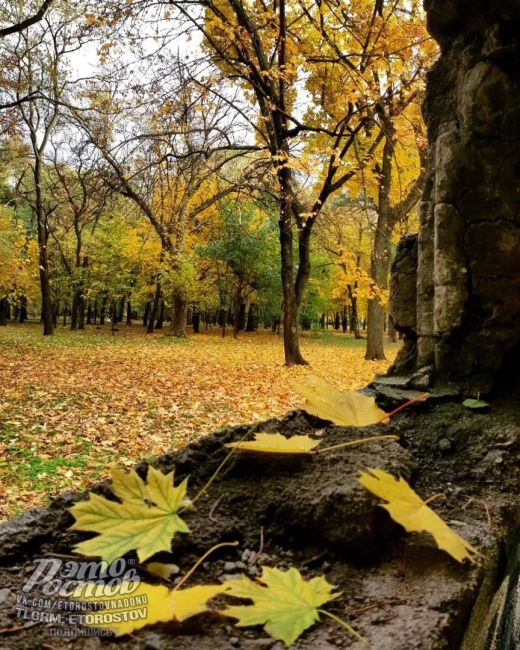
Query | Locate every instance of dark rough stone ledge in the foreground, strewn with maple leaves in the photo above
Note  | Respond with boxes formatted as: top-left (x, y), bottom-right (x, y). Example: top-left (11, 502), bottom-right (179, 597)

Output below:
top-left (0, 400), bottom-right (520, 650)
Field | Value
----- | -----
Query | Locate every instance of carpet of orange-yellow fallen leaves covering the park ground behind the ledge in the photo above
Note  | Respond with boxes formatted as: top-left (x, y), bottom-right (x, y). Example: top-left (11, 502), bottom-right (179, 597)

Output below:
top-left (0, 324), bottom-right (398, 518)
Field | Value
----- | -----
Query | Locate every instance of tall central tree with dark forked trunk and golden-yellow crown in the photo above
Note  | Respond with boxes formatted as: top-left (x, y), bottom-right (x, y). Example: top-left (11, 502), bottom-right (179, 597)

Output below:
top-left (161, 0), bottom-right (427, 365)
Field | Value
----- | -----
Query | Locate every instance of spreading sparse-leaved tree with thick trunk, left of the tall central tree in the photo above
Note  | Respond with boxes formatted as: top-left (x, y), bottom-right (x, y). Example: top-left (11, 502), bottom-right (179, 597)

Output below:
top-left (76, 62), bottom-right (256, 337)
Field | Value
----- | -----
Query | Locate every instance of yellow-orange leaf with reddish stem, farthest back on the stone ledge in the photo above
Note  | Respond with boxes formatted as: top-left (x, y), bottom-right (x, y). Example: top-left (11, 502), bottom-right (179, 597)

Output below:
top-left (292, 375), bottom-right (387, 427)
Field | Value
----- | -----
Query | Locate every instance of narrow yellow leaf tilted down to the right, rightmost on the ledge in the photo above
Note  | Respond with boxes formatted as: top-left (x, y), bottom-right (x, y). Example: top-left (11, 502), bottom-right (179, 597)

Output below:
top-left (359, 469), bottom-right (479, 562)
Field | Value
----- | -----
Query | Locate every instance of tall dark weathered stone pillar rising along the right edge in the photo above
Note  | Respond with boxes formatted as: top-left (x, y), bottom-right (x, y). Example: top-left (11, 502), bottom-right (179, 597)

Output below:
top-left (394, 0), bottom-right (520, 391)
